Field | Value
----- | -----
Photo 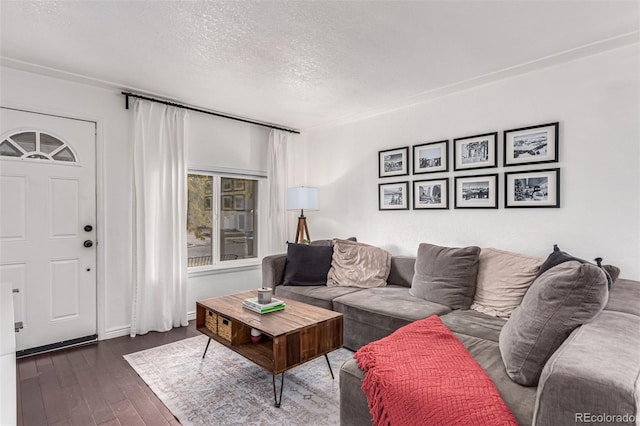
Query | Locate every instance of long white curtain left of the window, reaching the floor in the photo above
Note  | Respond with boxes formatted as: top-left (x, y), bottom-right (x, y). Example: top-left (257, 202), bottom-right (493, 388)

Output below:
top-left (131, 99), bottom-right (189, 337)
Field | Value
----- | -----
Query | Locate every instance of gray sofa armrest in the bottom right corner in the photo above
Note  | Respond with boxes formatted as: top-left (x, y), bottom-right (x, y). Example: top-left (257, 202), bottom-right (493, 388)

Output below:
top-left (533, 311), bottom-right (640, 425)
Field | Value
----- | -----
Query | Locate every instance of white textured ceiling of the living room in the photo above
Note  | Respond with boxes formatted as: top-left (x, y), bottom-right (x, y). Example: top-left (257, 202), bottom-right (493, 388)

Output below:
top-left (0, 0), bottom-right (640, 129)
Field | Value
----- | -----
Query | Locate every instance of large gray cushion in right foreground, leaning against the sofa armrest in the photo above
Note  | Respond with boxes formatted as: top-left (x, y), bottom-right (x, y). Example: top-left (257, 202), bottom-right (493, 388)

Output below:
top-left (499, 261), bottom-right (608, 386)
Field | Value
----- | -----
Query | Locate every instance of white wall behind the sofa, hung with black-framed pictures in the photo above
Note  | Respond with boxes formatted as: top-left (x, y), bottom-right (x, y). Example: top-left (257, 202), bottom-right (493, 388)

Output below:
top-left (297, 45), bottom-right (640, 279)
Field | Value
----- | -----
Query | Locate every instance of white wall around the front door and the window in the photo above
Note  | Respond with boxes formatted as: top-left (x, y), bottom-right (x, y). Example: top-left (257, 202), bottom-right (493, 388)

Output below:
top-left (0, 67), bottom-right (278, 339)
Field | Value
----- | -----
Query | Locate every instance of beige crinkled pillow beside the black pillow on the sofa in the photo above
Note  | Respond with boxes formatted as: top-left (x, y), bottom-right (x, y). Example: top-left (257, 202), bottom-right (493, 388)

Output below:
top-left (327, 240), bottom-right (391, 288)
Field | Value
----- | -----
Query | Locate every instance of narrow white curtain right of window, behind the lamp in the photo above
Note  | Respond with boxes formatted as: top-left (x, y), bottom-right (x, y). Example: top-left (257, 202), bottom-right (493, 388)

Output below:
top-left (265, 129), bottom-right (291, 254)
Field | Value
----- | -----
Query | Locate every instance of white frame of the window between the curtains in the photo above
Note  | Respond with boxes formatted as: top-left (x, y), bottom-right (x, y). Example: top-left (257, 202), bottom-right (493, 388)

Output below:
top-left (185, 166), bottom-right (267, 277)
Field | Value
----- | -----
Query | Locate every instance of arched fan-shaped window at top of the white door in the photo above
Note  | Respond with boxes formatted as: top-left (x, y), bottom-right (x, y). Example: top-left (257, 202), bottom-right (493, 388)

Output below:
top-left (0, 130), bottom-right (77, 163)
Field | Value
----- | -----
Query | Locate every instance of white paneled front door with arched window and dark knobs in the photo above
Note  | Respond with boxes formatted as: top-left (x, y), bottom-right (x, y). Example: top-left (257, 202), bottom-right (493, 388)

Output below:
top-left (0, 107), bottom-right (96, 354)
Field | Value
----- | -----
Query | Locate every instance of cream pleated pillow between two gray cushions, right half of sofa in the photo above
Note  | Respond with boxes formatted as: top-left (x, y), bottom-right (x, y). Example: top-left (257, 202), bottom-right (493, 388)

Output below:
top-left (471, 248), bottom-right (543, 318)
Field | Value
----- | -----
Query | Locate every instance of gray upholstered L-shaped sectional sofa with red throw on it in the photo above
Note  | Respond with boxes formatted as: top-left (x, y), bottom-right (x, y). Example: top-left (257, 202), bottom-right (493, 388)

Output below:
top-left (262, 250), bottom-right (640, 425)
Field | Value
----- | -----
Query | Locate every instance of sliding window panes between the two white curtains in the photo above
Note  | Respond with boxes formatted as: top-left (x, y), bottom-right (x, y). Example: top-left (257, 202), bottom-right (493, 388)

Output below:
top-left (187, 172), bottom-right (259, 268)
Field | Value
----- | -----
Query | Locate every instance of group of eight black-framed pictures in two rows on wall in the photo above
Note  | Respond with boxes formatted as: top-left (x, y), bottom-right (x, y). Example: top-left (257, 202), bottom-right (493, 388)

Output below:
top-left (378, 122), bottom-right (560, 210)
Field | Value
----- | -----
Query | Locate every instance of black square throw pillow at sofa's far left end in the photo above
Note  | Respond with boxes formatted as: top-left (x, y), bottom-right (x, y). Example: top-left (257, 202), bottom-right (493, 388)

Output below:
top-left (283, 243), bottom-right (333, 285)
